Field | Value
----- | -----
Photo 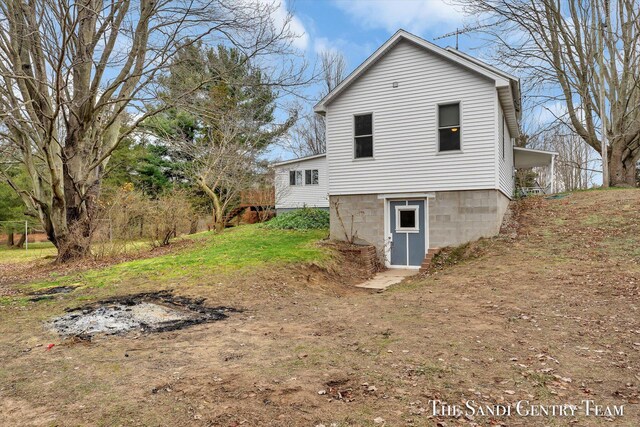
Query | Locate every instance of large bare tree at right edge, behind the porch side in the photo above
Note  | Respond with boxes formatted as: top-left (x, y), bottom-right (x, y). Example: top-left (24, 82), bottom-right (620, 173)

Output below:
top-left (459, 0), bottom-right (640, 186)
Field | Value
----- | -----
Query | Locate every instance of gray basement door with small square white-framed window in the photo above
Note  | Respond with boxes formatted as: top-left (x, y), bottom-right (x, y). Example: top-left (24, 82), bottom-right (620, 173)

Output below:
top-left (389, 200), bottom-right (427, 266)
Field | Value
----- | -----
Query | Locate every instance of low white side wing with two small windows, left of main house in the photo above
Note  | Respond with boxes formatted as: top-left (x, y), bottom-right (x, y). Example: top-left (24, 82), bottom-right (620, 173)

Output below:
top-left (274, 154), bottom-right (329, 213)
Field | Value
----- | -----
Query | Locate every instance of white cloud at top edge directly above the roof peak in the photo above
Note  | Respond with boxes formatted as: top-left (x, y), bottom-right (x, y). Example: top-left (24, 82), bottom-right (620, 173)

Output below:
top-left (335, 0), bottom-right (464, 33)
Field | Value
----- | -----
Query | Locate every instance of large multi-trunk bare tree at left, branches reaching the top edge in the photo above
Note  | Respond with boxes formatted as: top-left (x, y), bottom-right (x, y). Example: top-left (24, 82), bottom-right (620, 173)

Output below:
top-left (0, 0), bottom-right (298, 262)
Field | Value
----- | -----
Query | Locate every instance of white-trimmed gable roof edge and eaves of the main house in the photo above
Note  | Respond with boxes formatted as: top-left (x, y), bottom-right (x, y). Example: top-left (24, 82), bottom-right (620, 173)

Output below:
top-left (313, 29), bottom-right (520, 136)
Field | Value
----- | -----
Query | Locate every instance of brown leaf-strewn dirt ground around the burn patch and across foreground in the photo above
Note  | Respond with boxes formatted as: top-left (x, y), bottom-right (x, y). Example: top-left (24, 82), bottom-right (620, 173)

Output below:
top-left (0, 190), bottom-right (640, 427)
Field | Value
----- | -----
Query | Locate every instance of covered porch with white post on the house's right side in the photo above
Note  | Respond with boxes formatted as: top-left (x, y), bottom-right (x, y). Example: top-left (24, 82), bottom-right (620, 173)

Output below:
top-left (513, 147), bottom-right (558, 196)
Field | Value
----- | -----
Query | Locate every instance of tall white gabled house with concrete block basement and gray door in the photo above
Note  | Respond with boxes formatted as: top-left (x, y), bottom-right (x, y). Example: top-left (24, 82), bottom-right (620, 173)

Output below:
top-left (272, 30), bottom-right (554, 268)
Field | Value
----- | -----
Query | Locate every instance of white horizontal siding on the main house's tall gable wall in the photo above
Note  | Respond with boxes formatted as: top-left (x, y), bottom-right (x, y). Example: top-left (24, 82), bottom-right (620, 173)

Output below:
top-left (327, 41), bottom-right (498, 195)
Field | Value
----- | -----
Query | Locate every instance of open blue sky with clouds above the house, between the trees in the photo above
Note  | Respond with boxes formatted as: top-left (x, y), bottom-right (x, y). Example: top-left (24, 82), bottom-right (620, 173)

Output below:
top-left (264, 0), bottom-right (481, 159)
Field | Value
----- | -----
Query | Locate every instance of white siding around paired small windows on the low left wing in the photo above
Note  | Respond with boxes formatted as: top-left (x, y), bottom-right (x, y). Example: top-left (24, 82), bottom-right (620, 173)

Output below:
top-left (275, 157), bottom-right (329, 209)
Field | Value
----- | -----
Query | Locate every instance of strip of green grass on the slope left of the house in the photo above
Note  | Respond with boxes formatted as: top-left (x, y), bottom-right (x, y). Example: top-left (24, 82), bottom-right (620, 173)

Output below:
top-left (20, 225), bottom-right (330, 294)
